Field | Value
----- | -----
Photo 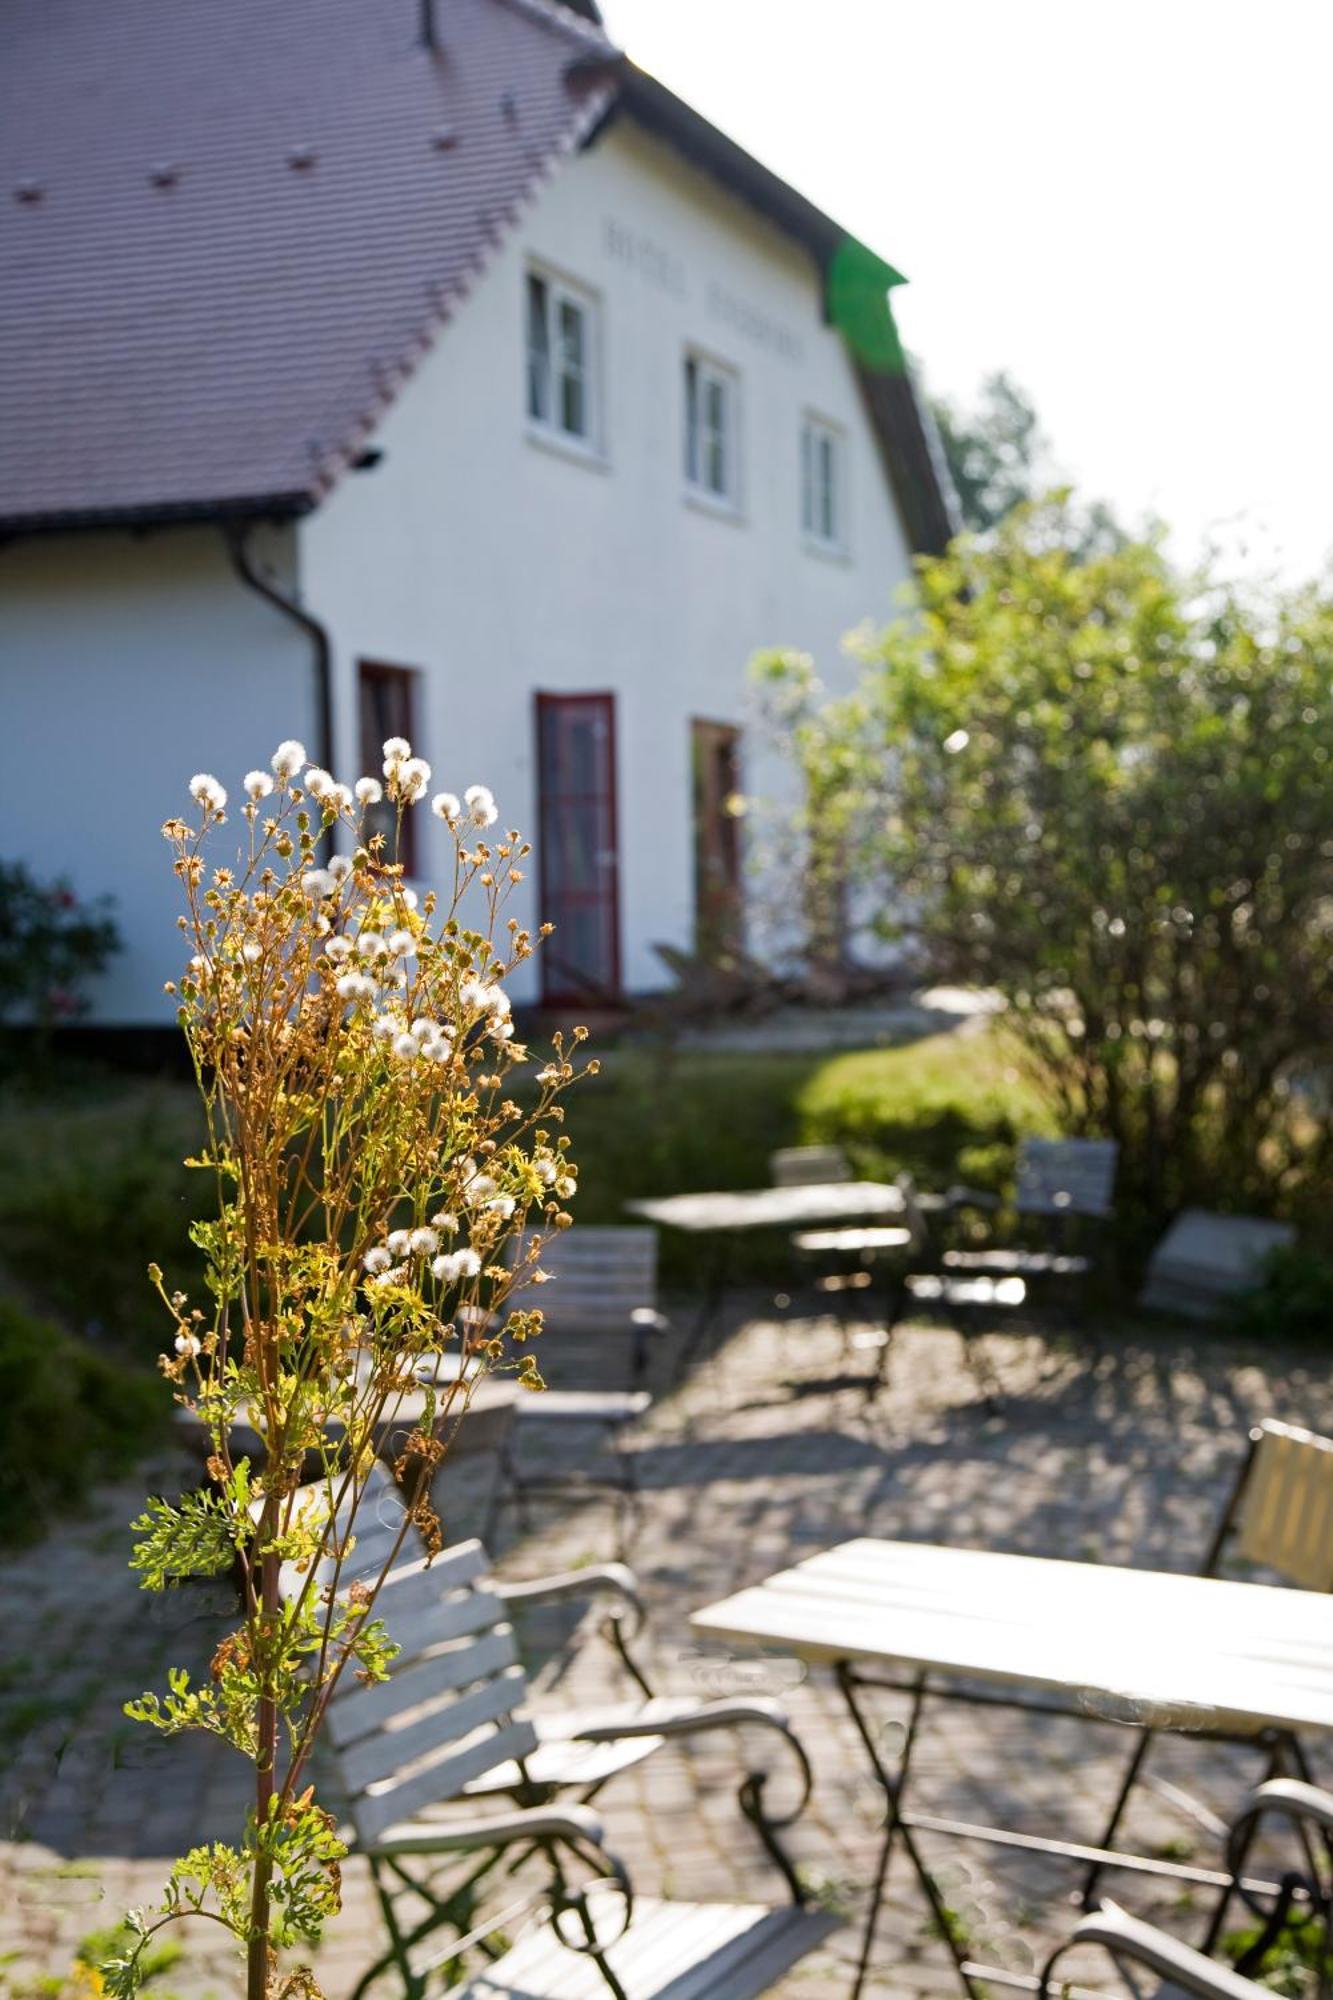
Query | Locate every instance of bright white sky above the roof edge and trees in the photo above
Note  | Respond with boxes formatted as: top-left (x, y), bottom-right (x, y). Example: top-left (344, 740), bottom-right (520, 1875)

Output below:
top-left (602, 0), bottom-right (1333, 580)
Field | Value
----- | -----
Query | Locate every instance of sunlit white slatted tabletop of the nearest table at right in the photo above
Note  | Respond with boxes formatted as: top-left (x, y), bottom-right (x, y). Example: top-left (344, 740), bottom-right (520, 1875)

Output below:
top-left (691, 1540), bottom-right (1333, 1734)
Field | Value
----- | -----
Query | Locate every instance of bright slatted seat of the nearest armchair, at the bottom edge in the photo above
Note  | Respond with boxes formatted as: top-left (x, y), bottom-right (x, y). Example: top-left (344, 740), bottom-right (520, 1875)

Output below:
top-left (456, 1898), bottom-right (839, 2000)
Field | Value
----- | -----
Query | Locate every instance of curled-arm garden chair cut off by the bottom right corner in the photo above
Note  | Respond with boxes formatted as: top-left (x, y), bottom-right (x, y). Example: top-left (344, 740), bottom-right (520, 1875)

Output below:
top-left (1037, 1778), bottom-right (1333, 2000)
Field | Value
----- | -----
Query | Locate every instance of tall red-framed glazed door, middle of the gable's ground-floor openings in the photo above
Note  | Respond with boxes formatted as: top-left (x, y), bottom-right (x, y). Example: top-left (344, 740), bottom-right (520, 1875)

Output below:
top-left (536, 694), bottom-right (620, 1004)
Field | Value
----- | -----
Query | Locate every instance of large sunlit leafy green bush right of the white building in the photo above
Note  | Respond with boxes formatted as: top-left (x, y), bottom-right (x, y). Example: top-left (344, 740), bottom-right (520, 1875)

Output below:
top-left (764, 496), bottom-right (1333, 1232)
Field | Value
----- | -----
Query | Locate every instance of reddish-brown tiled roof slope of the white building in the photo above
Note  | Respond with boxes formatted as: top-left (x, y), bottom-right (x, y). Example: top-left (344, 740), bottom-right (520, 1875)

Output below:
top-left (0, 0), bottom-right (614, 526)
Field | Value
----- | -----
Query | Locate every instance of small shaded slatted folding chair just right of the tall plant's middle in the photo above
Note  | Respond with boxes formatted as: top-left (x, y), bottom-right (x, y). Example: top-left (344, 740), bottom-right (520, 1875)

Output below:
top-left (484, 1226), bottom-right (669, 1538)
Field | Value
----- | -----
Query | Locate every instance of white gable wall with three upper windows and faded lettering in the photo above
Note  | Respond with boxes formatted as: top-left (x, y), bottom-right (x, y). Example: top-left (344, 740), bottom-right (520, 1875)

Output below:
top-left (298, 124), bottom-right (909, 996)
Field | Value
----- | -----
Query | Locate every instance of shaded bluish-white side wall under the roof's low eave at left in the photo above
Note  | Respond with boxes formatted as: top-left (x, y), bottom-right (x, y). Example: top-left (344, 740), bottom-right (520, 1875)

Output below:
top-left (0, 528), bottom-right (314, 1024)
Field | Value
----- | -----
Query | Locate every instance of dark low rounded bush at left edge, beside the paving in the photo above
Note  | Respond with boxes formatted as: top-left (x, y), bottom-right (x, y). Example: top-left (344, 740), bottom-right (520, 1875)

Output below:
top-left (0, 1298), bottom-right (168, 1544)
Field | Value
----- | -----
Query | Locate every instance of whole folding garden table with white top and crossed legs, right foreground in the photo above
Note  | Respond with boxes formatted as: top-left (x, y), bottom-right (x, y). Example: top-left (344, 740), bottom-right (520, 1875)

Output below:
top-left (691, 1540), bottom-right (1333, 2000)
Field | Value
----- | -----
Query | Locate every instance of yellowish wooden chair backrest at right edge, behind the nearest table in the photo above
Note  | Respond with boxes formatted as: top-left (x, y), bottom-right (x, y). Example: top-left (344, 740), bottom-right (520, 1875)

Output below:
top-left (1235, 1420), bottom-right (1333, 1590)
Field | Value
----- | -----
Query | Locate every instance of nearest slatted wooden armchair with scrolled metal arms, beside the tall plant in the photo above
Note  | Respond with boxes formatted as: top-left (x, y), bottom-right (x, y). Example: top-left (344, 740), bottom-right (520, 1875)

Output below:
top-left (282, 1480), bottom-right (829, 2000)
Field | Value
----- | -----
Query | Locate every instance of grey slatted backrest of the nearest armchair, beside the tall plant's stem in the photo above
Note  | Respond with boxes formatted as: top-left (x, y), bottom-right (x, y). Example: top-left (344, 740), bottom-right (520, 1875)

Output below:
top-left (282, 1468), bottom-right (536, 1844)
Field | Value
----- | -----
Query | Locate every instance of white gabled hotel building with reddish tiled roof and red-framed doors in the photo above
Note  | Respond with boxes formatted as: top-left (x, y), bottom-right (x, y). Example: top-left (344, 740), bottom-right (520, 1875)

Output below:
top-left (0, 0), bottom-right (949, 1024)
